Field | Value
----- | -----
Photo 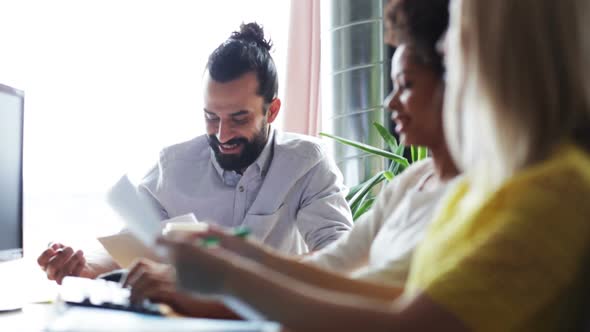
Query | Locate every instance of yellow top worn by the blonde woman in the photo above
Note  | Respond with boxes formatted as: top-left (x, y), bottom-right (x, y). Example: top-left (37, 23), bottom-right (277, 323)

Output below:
top-left (407, 145), bottom-right (590, 331)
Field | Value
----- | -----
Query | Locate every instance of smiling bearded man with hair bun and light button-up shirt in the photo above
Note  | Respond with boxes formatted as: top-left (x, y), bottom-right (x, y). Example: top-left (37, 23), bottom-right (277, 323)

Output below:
top-left (38, 23), bottom-right (352, 316)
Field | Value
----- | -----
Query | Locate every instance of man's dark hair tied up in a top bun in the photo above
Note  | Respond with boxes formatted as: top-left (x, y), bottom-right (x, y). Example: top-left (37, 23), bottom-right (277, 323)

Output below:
top-left (207, 22), bottom-right (279, 107)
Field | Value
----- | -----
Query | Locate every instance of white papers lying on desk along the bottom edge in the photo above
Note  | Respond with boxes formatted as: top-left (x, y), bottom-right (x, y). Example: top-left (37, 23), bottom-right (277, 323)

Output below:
top-left (46, 307), bottom-right (280, 332)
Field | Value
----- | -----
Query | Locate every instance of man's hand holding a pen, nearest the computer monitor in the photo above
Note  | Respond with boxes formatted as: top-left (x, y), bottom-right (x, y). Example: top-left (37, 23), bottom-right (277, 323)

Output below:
top-left (37, 243), bottom-right (94, 285)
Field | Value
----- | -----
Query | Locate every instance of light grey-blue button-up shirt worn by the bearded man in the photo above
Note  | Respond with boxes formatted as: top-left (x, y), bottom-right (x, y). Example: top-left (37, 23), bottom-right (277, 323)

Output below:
top-left (140, 129), bottom-right (352, 254)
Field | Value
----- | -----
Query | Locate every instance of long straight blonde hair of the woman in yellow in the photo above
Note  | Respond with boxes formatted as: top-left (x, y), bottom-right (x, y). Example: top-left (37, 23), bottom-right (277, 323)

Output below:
top-left (444, 0), bottom-right (590, 185)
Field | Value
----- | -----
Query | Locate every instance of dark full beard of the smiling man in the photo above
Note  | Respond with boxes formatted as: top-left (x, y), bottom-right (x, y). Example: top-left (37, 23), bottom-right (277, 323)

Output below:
top-left (207, 124), bottom-right (268, 173)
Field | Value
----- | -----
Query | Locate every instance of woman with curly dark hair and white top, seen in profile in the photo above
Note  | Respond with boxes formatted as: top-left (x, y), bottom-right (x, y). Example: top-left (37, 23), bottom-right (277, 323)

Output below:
top-left (304, 0), bottom-right (458, 288)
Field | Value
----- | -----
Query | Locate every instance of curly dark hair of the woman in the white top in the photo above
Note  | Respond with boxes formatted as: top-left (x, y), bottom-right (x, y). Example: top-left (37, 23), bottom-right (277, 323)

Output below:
top-left (384, 0), bottom-right (449, 75)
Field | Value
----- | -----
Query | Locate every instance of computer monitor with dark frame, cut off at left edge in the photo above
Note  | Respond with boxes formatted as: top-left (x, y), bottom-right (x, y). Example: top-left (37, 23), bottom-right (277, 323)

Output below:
top-left (0, 84), bottom-right (24, 262)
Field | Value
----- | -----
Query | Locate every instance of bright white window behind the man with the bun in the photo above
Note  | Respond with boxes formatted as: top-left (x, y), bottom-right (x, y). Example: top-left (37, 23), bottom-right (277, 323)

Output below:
top-left (0, 0), bottom-right (289, 257)
